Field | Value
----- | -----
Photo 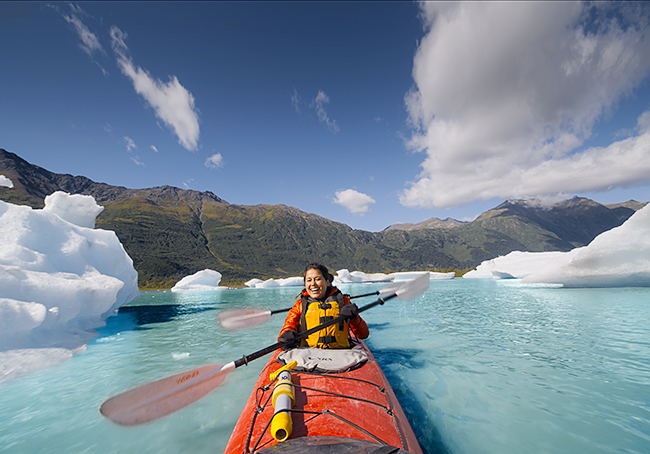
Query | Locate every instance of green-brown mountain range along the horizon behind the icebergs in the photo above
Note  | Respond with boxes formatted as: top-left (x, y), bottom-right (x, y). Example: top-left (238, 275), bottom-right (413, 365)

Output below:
top-left (0, 149), bottom-right (645, 288)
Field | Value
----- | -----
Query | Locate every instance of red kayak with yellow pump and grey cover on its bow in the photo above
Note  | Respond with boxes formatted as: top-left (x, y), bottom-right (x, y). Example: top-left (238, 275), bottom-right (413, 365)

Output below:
top-left (225, 339), bottom-right (422, 454)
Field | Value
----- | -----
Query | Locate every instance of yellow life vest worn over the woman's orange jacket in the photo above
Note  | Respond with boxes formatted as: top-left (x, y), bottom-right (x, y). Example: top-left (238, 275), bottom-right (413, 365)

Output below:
top-left (300, 288), bottom-right (350, 348)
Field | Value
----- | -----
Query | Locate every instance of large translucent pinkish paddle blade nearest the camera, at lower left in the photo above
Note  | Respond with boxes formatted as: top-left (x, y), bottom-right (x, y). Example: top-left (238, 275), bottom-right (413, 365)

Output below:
top-left (99, 363), bottom-right (234, 426)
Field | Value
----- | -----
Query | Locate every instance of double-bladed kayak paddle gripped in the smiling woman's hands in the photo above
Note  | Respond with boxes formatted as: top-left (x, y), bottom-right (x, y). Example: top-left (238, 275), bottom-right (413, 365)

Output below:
top-left (99, 275), bottom-right (429, 426)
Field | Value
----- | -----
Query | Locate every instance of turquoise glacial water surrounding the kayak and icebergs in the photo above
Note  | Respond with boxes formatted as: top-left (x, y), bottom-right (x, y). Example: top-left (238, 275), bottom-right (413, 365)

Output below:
top-left (0, 279), bottom-right (650, 454)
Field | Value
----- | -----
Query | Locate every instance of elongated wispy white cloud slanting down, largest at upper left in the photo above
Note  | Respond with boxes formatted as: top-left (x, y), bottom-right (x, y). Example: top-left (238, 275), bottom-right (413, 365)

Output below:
top-left (111, 26), bottom-right (200, 150)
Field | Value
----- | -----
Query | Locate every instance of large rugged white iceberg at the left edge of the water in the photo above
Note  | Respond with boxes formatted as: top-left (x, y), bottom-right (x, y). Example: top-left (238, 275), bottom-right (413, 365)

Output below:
top-left (0, 192), bottom-right (140, 381)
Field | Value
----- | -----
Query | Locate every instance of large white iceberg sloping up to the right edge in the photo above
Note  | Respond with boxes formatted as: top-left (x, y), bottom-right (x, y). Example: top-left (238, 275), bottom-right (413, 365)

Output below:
top-left (463, 205), bottom-right (650, 287)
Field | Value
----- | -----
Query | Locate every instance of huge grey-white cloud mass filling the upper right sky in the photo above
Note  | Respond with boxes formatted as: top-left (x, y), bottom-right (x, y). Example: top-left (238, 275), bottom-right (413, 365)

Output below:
top-left (400, 2), bottom-right (650, 208)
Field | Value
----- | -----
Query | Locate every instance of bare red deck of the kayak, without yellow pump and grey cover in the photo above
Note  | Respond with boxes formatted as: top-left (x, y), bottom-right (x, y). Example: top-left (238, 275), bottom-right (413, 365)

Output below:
top-left (225, 341), bottom-right (422, 454)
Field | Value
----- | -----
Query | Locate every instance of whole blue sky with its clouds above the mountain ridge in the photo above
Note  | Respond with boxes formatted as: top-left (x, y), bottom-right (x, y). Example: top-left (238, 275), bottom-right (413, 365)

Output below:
top-left (0, 2), bottom-right (650, 231)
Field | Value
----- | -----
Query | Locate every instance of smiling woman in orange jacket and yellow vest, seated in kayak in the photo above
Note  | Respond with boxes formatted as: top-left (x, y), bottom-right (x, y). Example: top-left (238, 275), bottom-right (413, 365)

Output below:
top-left (278, 263), bottom-right (369, 348)
